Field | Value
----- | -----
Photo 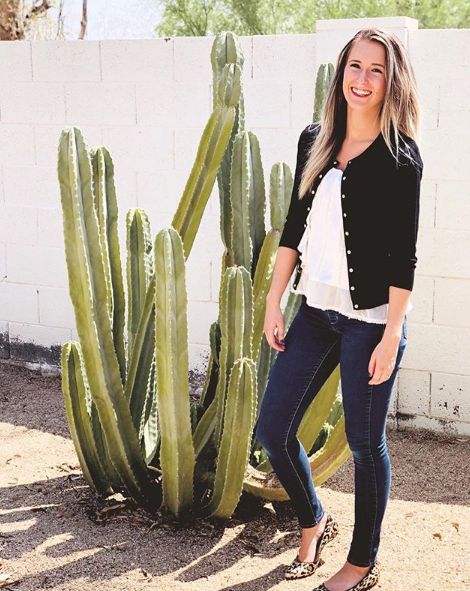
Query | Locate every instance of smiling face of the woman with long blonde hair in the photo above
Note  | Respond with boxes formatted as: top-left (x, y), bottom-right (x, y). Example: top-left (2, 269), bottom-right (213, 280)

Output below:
top-left (343, 39), bottom-right (386, 112)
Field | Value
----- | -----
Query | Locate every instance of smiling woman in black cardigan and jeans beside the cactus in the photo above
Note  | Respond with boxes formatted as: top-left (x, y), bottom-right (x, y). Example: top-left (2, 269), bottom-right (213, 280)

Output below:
top-left (256, 29), bottom-right (423, 591)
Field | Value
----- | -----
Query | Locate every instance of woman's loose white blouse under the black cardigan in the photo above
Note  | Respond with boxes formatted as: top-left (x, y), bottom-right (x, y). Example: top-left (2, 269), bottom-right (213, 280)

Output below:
top-left (290, 167), bottom-right (413, 324)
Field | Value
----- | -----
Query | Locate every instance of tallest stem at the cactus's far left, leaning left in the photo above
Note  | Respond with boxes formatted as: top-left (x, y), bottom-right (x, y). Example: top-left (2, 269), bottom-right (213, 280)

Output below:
top-left (58, 129), bottom-right (161, 511)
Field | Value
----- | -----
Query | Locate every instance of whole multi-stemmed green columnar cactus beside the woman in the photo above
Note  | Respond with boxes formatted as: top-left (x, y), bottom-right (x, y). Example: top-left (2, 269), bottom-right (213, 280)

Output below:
top-left (58, 32), bottom-right (350, 517)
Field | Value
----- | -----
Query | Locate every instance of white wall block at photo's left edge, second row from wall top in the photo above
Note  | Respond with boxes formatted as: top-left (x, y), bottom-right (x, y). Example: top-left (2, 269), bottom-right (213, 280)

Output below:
top-left (1, 82), bottom-right (65, 123)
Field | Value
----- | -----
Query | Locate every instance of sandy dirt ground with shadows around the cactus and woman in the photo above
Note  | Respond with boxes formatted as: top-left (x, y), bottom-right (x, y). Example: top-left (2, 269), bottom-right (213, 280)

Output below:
top-left (0, 363), bottom-right (470, 591)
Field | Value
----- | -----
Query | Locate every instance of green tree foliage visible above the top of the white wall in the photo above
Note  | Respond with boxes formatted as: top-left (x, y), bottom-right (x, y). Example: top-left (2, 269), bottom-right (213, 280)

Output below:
top-left (155, 0), bottom-right (470, 37)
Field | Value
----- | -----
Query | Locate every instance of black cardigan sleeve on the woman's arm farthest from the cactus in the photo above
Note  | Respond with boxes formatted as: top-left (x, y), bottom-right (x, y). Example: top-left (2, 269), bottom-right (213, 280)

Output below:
top-left (389, 150), bottom-right (423, 291)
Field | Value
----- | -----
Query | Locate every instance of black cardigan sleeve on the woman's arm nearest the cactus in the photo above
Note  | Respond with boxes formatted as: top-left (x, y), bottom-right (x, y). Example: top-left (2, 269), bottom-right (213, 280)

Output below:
top-left (279, 123), bottom-right (319, 252)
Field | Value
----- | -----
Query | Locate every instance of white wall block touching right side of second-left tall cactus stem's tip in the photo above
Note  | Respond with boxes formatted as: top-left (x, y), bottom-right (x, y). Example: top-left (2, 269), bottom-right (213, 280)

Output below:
top-left (103, 125), bottom-right (174, 171)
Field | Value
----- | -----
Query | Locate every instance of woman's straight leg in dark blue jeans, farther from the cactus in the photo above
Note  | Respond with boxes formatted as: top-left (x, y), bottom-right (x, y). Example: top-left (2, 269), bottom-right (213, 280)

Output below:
top-left (340, 317), bottom-right (407, 566)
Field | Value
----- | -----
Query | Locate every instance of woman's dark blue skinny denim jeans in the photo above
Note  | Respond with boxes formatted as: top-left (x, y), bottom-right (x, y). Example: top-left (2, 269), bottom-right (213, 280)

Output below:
top-left (255, 295), bottom-right (407, 566)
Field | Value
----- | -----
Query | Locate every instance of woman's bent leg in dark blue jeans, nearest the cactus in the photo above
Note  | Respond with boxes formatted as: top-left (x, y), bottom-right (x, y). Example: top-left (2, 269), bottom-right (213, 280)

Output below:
top-left (256, 298), bottom-right (341, 528)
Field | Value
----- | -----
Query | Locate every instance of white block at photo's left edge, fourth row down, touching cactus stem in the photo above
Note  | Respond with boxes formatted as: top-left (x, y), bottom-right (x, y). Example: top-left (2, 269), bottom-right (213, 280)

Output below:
top-left (3, 166), bottom-right (60, 209)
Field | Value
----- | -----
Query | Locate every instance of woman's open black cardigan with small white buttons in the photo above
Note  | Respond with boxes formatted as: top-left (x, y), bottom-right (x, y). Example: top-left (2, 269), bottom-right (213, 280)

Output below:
top-left (279, 123), bottom-right (423, 310)
